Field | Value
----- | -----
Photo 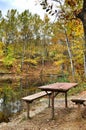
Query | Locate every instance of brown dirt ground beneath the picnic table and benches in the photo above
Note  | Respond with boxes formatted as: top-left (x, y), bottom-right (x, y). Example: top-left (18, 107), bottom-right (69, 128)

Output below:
top-left (0, 92), bottom-right (86, 130)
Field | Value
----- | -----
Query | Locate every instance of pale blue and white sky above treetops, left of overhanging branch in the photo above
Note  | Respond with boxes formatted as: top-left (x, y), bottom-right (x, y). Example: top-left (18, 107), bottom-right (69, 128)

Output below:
top-left (0, 0), bottom-right (45, 19)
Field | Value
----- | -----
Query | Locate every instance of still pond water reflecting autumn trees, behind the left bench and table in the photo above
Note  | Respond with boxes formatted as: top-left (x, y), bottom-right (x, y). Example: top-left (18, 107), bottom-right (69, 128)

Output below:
top-left (0, 75), bottom-right (63, 121)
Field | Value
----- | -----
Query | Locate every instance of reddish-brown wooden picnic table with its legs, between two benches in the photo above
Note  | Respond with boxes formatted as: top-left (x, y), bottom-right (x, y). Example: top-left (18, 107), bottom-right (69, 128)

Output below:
top-left (38, 82), bottom-right (78, 119)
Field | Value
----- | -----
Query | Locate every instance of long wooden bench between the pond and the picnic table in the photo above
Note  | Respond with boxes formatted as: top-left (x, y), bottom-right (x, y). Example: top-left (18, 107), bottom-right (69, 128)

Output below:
top-left (22, 91), bottom-right (51, 118)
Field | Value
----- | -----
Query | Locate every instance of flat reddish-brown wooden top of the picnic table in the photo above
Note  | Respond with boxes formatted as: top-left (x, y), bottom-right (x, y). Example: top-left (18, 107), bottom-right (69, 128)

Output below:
top-left (38, 82), bottom-right (78, 91)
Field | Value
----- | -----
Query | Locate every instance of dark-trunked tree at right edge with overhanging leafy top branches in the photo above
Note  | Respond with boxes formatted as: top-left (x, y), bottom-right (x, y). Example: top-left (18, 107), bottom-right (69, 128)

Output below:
top-left (40, 0), bottom-right (86, 77)
